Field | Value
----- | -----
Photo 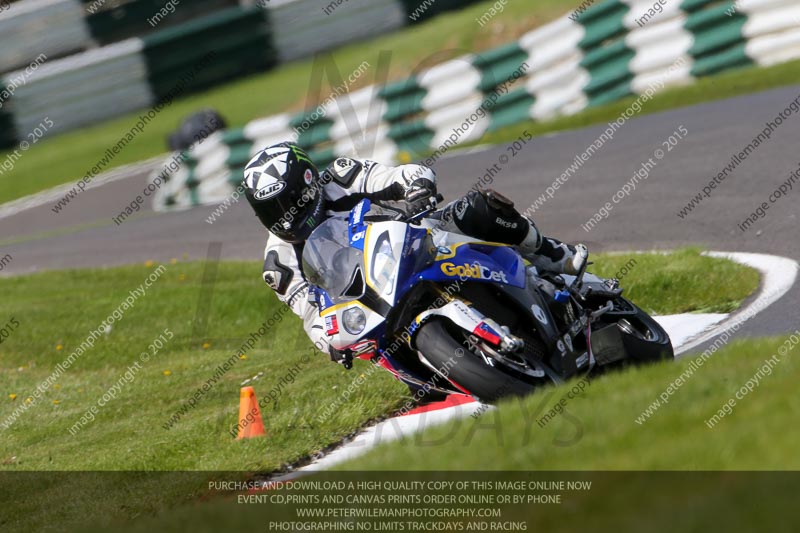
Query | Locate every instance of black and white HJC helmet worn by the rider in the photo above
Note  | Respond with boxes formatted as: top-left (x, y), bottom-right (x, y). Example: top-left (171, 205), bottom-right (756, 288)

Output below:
top-left (243, 142), bottom-right (325, 244)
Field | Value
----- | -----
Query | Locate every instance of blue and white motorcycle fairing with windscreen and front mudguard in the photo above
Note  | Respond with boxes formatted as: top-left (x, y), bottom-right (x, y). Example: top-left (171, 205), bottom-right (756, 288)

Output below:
top-left (303, 199), bottom-right (525, 356)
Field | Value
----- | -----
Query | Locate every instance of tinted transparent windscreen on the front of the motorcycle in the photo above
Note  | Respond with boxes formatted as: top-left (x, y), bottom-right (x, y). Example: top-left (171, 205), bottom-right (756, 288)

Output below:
top-left (303, 214), bottom-right (364, 303)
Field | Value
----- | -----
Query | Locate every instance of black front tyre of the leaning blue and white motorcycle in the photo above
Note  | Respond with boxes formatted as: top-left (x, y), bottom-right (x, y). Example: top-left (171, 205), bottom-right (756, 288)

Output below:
top-left (416, 319), bottom-right (534, 402)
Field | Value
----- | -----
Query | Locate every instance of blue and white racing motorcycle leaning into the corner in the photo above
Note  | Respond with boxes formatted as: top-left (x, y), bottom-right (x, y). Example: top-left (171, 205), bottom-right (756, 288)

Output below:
top-left (303, 198), bottom-right (674, 402)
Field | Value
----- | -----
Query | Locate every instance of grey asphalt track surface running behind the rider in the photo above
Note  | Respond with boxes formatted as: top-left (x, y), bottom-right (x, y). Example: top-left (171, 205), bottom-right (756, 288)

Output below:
top-left (0, 86), bottom-right (800, 336)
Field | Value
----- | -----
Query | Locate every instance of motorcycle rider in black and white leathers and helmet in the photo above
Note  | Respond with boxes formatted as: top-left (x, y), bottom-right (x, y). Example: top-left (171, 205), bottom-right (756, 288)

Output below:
top-left (243, 142), bottom-right (588, 369)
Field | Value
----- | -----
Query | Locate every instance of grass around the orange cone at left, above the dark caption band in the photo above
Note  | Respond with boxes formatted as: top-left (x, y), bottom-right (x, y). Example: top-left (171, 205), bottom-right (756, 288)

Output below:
top-left (0, 263), bottom-right (403, 470)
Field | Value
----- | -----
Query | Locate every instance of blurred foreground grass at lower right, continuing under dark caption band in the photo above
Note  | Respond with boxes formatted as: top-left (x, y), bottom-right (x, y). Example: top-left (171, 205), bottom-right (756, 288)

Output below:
top-left (70, 336), bottom-right (800, 533)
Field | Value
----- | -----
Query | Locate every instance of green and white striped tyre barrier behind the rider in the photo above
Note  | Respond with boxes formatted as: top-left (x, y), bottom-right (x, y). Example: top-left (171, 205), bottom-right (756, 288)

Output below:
top-left (157, 0), bottom-right (800, 208)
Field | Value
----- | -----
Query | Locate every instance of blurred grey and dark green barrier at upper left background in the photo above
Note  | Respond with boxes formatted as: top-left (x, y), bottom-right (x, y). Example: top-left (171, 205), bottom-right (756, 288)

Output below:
top-left (0, 0), bottom-right (478, 148)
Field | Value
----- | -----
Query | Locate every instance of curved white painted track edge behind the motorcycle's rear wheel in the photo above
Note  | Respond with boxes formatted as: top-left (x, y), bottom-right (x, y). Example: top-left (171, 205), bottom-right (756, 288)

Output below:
top-left (675, 252), bottom-right (800, 356)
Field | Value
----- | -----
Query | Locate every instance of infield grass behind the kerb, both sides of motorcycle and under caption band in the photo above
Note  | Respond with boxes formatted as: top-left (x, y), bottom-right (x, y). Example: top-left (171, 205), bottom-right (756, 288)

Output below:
top-left (0, 250), bottom-right (757, 530)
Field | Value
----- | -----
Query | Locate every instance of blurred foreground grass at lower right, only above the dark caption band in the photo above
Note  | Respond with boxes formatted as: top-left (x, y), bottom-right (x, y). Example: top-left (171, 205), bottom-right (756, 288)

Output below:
top-left (341, 331), bottom-right (800, 471)
